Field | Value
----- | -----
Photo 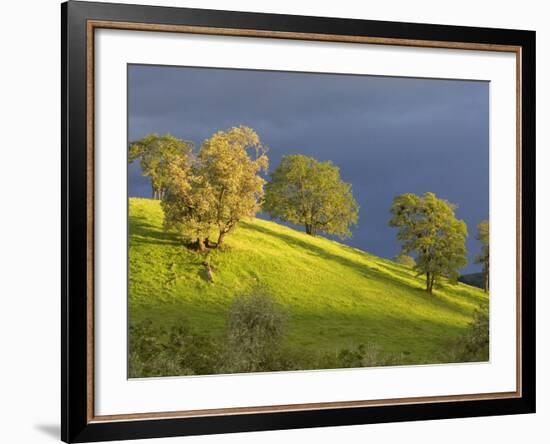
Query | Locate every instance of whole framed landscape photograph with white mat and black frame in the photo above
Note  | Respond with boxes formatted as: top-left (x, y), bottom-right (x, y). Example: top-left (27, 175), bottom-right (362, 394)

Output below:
top-left (61, 1), bottom-right (535, 442)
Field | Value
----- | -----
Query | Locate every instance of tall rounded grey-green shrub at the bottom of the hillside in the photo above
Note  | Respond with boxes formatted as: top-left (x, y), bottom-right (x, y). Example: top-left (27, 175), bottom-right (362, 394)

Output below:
top-left (222, 287), bottom-right (291, 373)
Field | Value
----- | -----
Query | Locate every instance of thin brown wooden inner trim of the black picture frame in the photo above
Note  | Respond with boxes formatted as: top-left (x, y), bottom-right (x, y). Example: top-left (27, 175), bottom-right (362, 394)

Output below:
top-left (86, 20), bottom-right (522, 423)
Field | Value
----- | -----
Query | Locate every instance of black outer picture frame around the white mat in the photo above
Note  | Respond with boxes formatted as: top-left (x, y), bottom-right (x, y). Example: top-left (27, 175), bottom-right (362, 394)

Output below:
top-left (61, 1), bottom-right (536, 442)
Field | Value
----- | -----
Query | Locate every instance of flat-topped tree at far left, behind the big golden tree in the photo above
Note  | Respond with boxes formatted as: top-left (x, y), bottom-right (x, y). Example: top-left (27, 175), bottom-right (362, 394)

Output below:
top-left (128, 134), bottom-right (193, 199)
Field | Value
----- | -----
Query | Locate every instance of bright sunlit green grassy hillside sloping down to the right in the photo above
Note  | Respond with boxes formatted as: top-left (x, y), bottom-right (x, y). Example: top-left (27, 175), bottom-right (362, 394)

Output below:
top-left (129, 198), bottom-right (488, 363)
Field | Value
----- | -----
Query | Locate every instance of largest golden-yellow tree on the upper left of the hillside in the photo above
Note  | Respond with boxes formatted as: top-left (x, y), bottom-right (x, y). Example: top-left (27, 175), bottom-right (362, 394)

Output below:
top-left (162, 126), bottom-right (268, 250)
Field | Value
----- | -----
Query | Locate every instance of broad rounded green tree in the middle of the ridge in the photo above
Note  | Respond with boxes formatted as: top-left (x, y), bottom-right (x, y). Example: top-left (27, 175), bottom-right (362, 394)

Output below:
top-left (263, 154), bottom-right (359, 238)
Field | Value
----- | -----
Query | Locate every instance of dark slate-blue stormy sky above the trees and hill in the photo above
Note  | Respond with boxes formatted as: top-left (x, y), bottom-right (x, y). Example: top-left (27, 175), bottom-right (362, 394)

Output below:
top-left (128, 65), bottom-right (489, 272)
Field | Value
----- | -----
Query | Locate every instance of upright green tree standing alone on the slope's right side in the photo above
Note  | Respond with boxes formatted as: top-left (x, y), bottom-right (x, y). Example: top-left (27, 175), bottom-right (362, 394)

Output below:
top-left (389, 193), bottom-right (468, 293)
